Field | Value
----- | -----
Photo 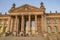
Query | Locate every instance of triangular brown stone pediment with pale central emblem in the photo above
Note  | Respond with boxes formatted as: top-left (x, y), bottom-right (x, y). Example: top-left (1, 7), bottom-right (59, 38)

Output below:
top-left (10, 4), bottom-right (39, 12)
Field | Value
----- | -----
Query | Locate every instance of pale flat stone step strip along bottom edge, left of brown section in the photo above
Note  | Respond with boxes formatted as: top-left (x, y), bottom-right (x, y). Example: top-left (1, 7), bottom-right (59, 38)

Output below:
top-left (0, 36), bottom-right (45, 40)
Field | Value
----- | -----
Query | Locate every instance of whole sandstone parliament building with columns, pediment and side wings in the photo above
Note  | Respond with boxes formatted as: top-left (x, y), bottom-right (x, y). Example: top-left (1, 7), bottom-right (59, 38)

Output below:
top-left (0, 2), bottom-right (60, 37)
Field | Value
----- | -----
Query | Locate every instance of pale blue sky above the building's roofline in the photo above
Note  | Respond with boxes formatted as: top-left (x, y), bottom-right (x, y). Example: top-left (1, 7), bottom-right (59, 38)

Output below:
top-left (0, 0), bottom-right (60, 14)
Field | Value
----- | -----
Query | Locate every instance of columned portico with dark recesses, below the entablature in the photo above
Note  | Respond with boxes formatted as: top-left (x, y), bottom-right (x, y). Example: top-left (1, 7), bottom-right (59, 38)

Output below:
top-left (10, 15), bottom-right (41, 34)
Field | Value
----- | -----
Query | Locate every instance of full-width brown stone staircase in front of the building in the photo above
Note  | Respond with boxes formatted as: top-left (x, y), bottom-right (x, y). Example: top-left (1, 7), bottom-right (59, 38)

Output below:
top-left (0, 34), bottom-right (60, 40)
